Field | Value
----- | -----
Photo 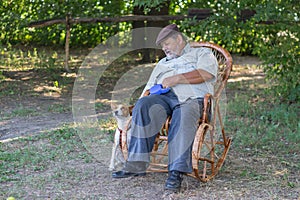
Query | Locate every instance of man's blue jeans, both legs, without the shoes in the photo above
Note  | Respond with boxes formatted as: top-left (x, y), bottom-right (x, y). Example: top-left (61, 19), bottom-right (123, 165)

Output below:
top-left (128, 90), bottom-right (203, 173)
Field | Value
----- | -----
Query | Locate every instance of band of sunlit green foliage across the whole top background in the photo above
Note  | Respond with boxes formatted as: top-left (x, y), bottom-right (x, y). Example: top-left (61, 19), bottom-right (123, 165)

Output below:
top-left (0, 0), bottom-right (300, 101)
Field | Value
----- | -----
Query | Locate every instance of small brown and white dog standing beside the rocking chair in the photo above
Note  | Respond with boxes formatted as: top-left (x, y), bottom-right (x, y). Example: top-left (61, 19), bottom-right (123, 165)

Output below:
top-left (109, 105), bottom-right (132, 171)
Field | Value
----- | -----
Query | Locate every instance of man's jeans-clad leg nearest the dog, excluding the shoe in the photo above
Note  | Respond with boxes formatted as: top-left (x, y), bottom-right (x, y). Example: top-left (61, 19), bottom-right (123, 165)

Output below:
top-left (128, 92), bottom-right (178, 162)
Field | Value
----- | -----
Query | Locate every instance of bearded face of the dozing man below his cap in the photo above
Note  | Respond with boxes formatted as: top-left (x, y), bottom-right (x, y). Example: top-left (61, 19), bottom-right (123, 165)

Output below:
top-left (161, 36), bottom-right (181, 59)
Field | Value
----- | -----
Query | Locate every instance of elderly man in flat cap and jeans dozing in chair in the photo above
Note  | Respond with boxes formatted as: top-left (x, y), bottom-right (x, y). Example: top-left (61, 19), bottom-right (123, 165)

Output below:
top-left (112, 24), bottom-right (217, 191)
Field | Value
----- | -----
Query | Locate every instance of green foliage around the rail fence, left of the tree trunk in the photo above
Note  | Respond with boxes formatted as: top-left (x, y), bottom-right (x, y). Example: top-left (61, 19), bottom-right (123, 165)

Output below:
top-left (0, 0), bottom-right (128, 46)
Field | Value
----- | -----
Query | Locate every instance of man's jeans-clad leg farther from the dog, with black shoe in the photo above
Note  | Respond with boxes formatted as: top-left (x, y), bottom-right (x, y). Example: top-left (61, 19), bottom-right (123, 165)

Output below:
top-left (165, 99), bottom-right (203, 191)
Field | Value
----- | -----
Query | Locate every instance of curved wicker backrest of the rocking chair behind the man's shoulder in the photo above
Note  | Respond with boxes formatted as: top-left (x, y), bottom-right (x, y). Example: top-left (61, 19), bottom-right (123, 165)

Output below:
top-left (190, 42), bottom-right (232, 98)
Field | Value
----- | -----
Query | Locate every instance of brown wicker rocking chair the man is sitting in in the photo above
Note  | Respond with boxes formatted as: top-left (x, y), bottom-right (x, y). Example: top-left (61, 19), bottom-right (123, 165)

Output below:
top-left (121, 42), bottom-right (232, 182)
